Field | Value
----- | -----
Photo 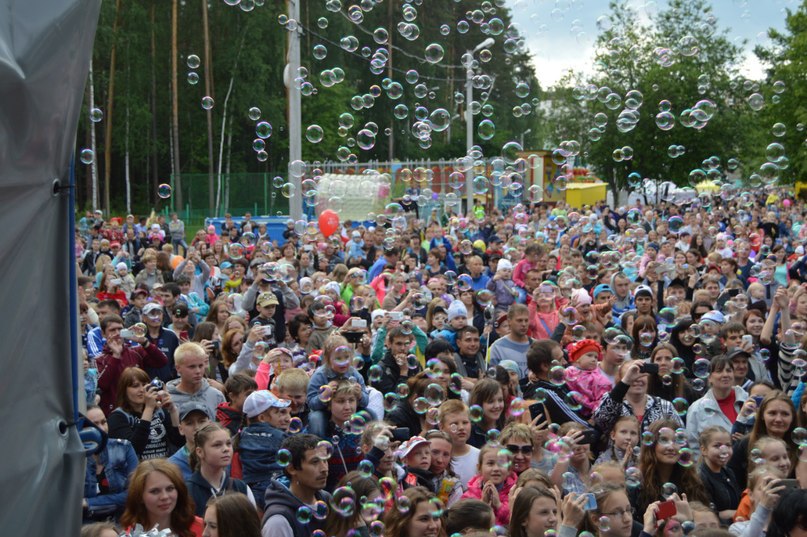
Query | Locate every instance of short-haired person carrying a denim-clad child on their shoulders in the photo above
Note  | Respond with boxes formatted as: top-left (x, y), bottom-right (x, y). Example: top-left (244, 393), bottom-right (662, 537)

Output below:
top-left (325, 379), bottom-right (364, 490)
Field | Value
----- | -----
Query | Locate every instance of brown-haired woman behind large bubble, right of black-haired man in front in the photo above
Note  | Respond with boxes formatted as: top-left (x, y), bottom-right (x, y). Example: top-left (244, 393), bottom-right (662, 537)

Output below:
top-left (324, 470), bottom-right (384, 537)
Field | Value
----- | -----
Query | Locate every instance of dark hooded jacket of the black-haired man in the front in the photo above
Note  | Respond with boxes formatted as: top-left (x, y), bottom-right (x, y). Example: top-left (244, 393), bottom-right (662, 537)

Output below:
top-left (261, 479), bottom-right (330, 537)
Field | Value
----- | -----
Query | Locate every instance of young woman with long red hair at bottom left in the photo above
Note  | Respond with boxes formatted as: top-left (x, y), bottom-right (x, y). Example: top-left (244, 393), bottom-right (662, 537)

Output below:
top-left (120, 459), bottom-right (202, 537)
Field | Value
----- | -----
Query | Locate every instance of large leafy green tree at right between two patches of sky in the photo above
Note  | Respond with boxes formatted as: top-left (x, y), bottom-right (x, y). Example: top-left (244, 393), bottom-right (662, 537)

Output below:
top-left (550, 0), bottom-right (754, 202)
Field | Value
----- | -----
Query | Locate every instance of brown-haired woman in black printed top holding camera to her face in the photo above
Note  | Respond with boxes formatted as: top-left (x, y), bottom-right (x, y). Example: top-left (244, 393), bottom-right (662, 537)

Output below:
top-left (108, 367), bottom-right (185, 460)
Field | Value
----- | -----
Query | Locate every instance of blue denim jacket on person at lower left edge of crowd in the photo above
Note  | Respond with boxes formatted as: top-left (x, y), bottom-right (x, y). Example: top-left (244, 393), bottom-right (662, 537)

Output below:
top-left (84, 438), bottom-right (138, 515)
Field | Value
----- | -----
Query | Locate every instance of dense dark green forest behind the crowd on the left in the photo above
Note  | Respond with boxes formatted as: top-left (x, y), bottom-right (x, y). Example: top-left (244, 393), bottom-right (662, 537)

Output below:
top-left (77, 0), bottom-right (544, 213)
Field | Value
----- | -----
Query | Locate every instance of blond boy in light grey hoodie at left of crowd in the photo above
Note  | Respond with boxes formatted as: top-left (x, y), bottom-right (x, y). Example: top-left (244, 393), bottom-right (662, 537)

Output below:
top-left (166, 343), bottom-right (225, 416)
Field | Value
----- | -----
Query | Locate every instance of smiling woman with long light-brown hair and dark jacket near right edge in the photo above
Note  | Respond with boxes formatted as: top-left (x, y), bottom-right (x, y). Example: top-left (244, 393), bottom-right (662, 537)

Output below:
top-left (729, 390), bottom-right (798, 489)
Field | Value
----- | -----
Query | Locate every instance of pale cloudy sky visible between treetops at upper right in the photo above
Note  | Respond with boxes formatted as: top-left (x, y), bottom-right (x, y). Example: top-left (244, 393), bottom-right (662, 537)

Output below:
top-left (507, 0), bottom-right (799, 88)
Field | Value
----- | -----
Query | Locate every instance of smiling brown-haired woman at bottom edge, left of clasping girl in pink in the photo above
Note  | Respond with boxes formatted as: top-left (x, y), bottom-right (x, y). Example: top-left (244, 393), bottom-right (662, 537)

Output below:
top-left (384, 487), bottom-right (446, 537)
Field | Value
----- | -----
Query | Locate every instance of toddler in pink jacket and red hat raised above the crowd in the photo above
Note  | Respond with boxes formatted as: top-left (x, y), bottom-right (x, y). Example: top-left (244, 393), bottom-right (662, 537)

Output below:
top-left (566, 339), bottom-right (613, 418)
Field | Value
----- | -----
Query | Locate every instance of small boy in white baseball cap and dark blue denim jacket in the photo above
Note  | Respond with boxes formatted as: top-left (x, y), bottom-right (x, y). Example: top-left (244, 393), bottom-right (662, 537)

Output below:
top-left (238, 390), bottom-right (291, 509)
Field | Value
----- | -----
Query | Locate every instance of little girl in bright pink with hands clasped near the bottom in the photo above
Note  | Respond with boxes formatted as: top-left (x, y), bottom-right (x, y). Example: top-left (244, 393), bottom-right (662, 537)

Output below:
top-left (462, 444), bottom-right (518, 526)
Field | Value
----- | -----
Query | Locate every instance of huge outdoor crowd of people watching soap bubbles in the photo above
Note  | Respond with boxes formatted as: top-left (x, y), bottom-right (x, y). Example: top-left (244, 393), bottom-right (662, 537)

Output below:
top-left (76, 189), bottom-right (807, 537)
